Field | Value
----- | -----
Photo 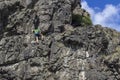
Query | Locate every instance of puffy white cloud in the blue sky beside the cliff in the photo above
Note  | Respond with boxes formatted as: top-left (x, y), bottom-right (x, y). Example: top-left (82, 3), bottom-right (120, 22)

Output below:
top-left (82, 0), bottom-right (120, 31)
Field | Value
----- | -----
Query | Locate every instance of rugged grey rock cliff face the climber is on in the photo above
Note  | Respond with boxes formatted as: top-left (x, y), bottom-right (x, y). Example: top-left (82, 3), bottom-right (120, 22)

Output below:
top-left (0, 0), bottom-right (120, 80)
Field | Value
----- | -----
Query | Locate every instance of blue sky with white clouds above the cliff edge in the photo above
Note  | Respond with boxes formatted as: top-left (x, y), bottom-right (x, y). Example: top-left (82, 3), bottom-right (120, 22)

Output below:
top-left (81, 0), bottom-right (120, 31)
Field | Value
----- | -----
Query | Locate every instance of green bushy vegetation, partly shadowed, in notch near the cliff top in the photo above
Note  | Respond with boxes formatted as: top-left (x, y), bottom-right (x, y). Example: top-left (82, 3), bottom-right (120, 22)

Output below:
top-left (72, 14), bottom-right (92, 26)
